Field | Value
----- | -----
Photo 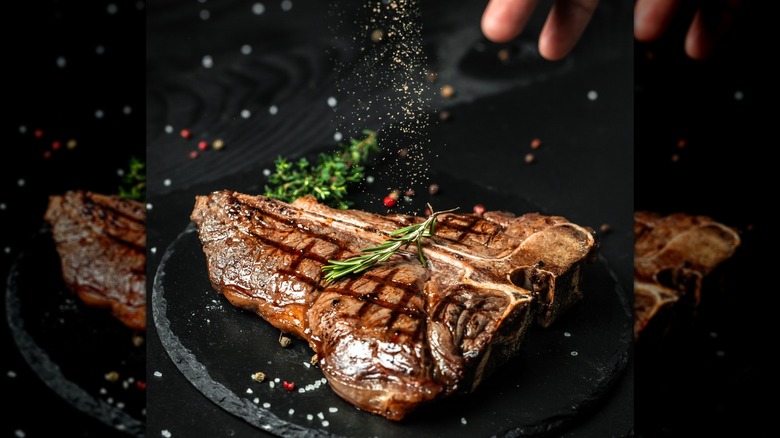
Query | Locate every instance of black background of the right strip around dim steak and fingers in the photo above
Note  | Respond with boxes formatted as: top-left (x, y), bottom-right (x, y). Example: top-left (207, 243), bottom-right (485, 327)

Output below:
top-left (634, 2), bottom-right (777, 436)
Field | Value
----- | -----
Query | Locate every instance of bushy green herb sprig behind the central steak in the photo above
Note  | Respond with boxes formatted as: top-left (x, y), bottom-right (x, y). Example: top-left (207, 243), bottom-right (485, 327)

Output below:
top-left (265, 130), bottom-right (379, 210)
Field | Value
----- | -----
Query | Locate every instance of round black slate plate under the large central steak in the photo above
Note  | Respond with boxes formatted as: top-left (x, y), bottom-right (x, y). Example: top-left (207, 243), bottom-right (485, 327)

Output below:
top-left (151, 169), bottom-right (631, 437)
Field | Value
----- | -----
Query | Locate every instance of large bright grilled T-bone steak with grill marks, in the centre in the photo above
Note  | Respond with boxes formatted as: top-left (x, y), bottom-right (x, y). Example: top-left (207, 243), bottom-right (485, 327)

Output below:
top-left (191, 190), bottom-right (597, 420)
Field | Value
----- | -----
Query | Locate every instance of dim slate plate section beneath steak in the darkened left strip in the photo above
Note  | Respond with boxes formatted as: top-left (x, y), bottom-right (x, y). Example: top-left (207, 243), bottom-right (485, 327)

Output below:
top-left (5, 224), bottom-right (146, 437)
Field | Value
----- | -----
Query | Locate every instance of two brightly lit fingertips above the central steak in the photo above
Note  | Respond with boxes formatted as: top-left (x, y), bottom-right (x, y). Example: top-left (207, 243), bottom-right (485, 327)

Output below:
top-left (481, 0), bottom-right (598, 61)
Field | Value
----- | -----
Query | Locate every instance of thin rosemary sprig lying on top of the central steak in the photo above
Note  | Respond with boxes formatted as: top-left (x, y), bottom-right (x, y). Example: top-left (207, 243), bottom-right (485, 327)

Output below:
top-left (322, 204), bottom-right (457, 284)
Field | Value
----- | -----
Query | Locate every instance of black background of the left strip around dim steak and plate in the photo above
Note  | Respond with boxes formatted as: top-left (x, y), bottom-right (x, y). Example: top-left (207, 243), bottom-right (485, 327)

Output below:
top-left (0, 0), bottom-right (145, 437)
